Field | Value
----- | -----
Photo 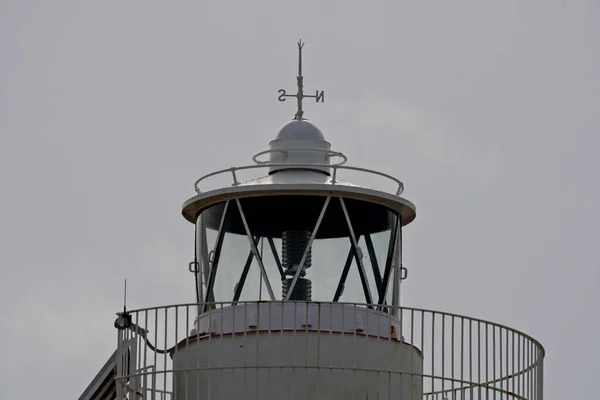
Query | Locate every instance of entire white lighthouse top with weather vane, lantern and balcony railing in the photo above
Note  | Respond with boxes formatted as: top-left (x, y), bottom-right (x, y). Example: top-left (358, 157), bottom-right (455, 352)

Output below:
top-left (80, 42), bottom-right (544, 400)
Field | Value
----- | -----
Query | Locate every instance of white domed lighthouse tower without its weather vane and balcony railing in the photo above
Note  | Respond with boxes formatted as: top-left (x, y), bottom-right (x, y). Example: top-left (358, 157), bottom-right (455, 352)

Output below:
top-left (173, 112), bottom-right (422, 400)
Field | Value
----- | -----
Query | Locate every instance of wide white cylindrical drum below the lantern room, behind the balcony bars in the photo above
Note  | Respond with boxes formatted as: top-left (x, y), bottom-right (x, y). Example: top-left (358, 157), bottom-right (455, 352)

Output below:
top-left (173, 331), bottom-right (423, 400)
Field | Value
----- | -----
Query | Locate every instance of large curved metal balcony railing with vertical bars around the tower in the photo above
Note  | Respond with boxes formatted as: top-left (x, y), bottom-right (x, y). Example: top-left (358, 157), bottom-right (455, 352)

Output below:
top-left (116, 301), bottom-right (545, 400)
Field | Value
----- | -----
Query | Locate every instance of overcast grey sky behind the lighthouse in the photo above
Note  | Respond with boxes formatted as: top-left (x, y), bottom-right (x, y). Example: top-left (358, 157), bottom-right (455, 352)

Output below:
top-left (0, 0), bottom-right (600, 399)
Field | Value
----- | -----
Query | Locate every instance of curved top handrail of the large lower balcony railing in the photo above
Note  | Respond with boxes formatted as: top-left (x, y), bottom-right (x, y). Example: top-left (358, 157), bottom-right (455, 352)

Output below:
top-left (117, 300), bottom-right (546, 359)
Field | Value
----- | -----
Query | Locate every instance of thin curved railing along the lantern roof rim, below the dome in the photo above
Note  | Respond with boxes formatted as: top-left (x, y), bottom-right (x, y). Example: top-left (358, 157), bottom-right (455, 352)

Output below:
top-left (194, 163), bottom-right (404, 196)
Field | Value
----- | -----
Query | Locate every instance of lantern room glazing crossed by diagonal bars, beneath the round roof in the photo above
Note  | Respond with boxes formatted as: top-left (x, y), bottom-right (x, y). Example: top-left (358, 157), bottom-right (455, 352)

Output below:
top-left (197, 195), bottom-right (397, 304)
